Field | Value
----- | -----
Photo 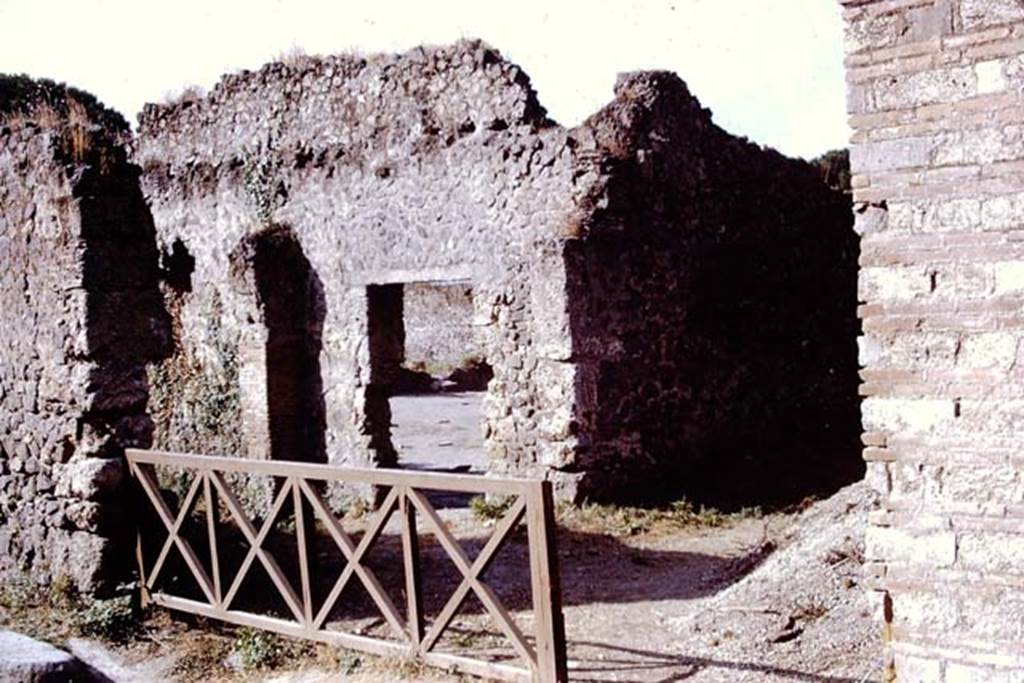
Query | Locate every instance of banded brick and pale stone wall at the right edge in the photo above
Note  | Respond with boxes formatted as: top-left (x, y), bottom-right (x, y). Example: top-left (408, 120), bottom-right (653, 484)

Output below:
top-left (843, 0), bottom-right (1024, 682)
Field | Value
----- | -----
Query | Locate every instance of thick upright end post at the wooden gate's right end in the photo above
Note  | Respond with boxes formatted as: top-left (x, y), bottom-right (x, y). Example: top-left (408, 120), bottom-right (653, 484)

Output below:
top-left (526, 481), bottom-right (568, 683)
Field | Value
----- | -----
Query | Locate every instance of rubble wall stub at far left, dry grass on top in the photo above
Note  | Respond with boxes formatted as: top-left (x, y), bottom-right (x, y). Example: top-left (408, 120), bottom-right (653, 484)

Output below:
top-left (0, 77), bottom-right (168, 592)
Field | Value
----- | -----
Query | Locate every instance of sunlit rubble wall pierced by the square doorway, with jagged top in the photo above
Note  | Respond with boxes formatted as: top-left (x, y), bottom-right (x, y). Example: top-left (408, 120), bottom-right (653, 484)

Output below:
top-left (136, 41), bottom-right (573, 489)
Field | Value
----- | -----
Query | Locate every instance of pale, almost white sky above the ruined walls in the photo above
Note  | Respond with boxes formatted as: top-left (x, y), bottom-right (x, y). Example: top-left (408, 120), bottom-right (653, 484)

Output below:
top-left (0, 0), bottom-right (849, 157)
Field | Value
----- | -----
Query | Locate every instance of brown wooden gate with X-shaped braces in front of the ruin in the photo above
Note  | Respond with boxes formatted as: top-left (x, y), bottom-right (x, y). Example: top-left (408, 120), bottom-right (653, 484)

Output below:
top-left (127, 450), bottom-right (566, 683)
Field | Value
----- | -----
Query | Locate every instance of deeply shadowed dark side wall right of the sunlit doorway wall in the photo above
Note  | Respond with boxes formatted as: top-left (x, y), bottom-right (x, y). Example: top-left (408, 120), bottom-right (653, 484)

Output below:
top-left (565, 72), bottom-right (863, 504)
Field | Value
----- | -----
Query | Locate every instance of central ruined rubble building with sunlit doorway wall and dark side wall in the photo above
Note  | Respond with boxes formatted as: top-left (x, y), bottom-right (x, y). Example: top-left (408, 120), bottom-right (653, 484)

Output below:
top-left (135, 41), bottom-right (862, 500)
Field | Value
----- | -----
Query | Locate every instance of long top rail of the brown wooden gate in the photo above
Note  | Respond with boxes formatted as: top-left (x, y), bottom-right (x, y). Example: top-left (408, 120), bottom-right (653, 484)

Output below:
top-left (125, 449), bottom-right (531, 496)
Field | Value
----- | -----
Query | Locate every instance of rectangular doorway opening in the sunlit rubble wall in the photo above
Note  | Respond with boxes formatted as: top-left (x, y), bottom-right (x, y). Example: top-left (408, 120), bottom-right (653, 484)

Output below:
top-left (367, 283), bottom-right (494, 473)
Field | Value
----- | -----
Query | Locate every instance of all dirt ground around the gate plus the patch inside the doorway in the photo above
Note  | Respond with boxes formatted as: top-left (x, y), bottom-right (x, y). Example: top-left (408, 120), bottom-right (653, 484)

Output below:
top-left (0, 394), bottom-right (882, 683)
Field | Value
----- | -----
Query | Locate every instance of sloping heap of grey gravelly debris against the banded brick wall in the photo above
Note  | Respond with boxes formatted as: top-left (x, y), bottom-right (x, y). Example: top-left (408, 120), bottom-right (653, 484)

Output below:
top-left (676, 481), bottom-right (882, 680)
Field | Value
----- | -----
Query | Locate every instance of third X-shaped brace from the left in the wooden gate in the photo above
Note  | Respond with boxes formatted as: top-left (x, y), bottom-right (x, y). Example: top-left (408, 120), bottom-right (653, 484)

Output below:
top-left (299, 479), bottom-right (410, 640)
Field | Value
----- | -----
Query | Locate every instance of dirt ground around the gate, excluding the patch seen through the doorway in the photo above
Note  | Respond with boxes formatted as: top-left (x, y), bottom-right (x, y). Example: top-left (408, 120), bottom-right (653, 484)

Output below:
top-left (0, 484), bottom-right (881, 683)
